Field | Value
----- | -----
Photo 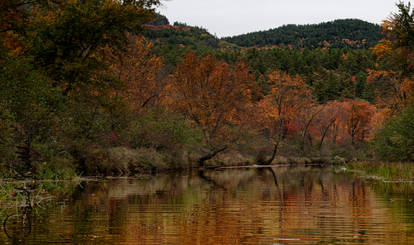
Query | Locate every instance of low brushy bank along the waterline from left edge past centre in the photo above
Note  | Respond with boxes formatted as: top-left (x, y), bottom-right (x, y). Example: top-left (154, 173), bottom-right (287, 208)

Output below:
top-left (0, 144), bottom-right (346, 180)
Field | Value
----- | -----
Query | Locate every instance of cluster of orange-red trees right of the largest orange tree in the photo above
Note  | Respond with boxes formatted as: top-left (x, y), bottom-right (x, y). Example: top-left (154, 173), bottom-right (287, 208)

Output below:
top-left (256, 71), bottom-right (376, 163)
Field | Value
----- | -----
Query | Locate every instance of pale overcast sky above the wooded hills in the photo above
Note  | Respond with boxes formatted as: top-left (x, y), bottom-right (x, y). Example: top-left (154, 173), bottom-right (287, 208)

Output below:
top-left (158, 0), bottom-right (408, 37)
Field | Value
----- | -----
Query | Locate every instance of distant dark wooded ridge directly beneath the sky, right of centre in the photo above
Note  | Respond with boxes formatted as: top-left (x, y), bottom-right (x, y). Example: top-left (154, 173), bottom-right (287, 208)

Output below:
top-left (223, 19), bottom-right (382, 49)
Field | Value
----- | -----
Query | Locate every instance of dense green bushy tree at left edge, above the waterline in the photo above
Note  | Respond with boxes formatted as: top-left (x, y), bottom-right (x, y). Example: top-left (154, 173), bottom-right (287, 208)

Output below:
top-left (0, 59), bottom-right (61, 177)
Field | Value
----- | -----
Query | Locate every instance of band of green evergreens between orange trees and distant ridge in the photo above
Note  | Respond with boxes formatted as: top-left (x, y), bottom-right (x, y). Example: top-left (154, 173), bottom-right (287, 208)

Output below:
top-left (214, 48), bottom-right (383, 103)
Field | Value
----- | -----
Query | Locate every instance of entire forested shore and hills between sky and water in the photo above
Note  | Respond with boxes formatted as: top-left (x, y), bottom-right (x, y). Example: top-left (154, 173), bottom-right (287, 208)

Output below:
top-left (0, 0), bottom-right (414, 178)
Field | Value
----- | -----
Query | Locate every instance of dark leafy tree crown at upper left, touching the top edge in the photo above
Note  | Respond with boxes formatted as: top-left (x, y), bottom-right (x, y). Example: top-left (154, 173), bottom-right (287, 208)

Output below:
top-left (30, 0), bottom-right (158, 94)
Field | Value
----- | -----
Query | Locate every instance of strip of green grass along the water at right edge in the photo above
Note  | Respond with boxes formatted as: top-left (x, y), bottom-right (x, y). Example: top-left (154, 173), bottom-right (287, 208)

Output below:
top-left (346, 162), bottom-right (414, 181)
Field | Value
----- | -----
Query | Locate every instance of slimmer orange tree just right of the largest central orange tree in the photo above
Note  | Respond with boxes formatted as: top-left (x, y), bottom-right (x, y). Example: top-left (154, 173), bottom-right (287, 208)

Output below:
top-left (257, 71), bottom-right (313, 164)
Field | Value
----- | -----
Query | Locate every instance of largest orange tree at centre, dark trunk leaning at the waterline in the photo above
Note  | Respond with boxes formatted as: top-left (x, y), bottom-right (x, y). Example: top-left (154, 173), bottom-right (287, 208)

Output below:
top-left (166, 52), bottom-right (251, 165)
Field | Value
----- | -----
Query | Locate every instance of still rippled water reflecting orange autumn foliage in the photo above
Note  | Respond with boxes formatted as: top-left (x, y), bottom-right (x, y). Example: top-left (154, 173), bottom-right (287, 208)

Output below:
top-left (0, 167), bottom-right (414, 245)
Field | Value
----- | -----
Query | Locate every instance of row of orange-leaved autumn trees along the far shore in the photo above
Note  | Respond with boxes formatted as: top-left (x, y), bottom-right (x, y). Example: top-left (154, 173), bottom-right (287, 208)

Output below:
top-left (115, 37), bottom-right (376, 164)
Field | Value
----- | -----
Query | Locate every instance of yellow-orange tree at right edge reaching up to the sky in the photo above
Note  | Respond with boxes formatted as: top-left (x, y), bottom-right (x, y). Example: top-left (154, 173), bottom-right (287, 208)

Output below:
top-left (368, 3), bottom-right (414, 117)
